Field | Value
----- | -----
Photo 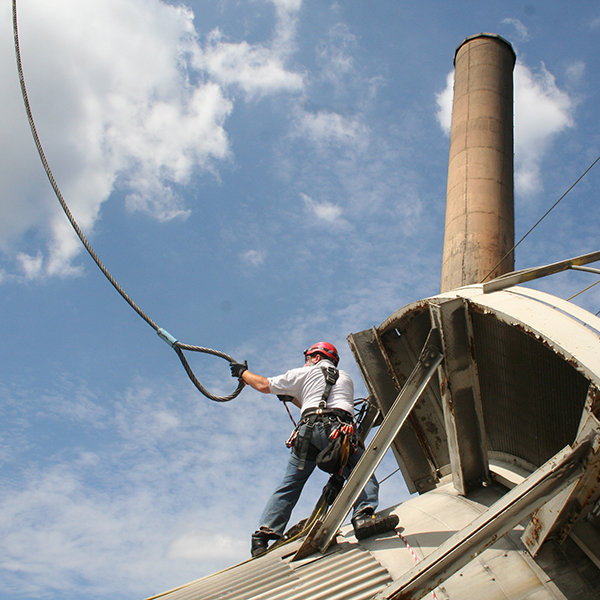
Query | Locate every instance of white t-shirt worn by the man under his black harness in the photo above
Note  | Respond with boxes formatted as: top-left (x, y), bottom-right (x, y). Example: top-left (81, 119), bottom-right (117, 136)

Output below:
top-left (268, 360), bottom-right (354, 415)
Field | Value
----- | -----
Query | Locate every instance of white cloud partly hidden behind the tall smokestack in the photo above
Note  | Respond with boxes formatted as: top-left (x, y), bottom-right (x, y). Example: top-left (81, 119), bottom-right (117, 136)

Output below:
top-left (436, 63), bottom-right (581, 195)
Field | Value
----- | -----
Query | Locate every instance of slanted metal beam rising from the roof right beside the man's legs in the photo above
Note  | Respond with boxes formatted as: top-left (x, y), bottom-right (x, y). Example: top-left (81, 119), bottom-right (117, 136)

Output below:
top-left (292, 329), bottom-right (444, 560)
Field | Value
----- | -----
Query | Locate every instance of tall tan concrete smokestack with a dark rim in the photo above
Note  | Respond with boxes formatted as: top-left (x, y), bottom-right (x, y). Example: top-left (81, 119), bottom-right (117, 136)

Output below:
top-left (441, 33), bottom-right (516, 292)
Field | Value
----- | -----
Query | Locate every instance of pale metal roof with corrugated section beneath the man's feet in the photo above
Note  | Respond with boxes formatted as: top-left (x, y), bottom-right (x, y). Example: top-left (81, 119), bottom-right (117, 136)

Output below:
top-left (149, 484), bottom-right (600, 600)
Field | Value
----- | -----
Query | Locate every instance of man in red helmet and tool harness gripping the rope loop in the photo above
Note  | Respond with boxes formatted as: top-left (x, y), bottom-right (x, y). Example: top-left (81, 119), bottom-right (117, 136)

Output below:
top-left (231, 342), bottom-right (398, 556)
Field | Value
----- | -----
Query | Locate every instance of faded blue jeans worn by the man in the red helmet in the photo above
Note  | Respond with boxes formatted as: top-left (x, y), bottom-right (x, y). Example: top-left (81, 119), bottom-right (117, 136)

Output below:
top-left (260, 422), bottom-right (379, 535)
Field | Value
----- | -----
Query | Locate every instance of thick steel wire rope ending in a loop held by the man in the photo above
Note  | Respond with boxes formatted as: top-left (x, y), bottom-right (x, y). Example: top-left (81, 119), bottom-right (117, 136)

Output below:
top-left (12, 0), bottom-right (245, 402)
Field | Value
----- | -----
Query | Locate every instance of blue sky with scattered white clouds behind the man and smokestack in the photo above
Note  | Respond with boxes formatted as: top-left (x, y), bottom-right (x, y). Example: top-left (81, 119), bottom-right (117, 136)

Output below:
top-left (0, 0), bottom-right (600, 600)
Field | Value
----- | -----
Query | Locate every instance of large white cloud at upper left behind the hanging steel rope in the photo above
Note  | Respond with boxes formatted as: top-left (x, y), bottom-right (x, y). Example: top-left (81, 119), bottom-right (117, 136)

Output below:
top-left (0, 0), bottom-right (232, 278)
